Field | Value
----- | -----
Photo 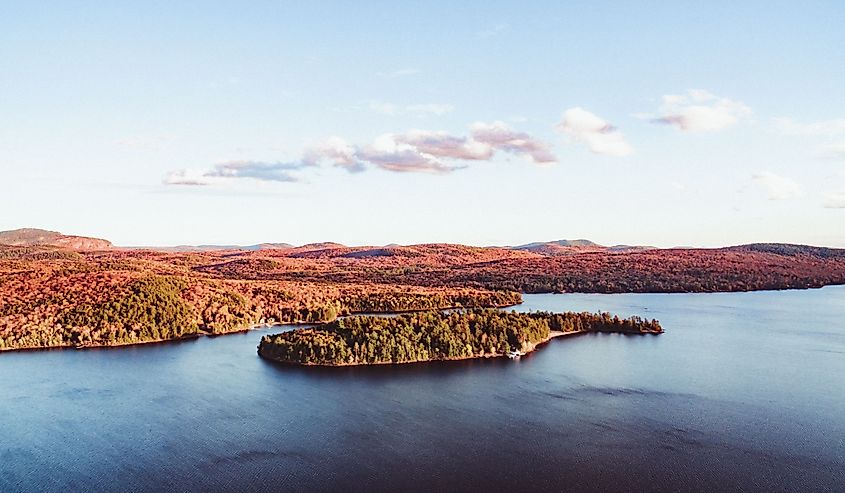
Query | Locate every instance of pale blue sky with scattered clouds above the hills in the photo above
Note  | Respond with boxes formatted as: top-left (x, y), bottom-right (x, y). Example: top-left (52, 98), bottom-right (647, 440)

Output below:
top-left (0, 0), bottom-right (845, 247)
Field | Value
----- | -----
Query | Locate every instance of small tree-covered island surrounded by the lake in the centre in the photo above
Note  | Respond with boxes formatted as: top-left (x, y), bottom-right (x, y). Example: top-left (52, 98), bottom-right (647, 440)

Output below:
top-left (258, 309), bottom-right (663, 366)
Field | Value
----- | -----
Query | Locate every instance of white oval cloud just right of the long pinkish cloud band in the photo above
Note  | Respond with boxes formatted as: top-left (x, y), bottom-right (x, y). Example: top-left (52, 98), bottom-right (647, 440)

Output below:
top-left (557, 107), bottom-right (634, 156)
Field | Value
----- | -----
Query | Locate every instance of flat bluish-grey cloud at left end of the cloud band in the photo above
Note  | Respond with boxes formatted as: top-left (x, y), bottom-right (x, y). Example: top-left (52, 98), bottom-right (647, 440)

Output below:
top-left (164, 161), bottom-right (308, 186)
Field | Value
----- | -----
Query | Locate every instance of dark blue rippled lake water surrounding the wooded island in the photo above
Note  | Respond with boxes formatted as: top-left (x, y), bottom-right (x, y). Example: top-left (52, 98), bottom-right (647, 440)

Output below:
top-left (0, 287), bottom-right (845, 492)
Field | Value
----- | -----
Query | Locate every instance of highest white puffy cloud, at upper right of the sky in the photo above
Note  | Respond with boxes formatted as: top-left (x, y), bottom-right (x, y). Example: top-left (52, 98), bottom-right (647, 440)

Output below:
top-left (652, 89), bottom-right (751, 132)
